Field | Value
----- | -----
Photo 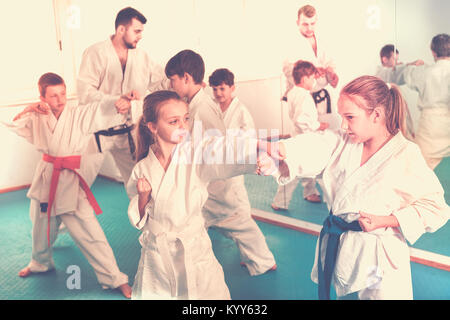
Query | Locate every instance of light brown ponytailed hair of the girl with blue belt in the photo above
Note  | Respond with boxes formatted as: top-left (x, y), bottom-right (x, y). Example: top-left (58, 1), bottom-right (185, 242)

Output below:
top-left (341, 76), bottom-right (414, 139)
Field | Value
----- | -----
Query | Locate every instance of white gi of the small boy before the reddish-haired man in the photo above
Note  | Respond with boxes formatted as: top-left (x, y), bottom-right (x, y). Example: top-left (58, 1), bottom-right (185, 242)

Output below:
top-left (273, 86), bottom-right (320, 209)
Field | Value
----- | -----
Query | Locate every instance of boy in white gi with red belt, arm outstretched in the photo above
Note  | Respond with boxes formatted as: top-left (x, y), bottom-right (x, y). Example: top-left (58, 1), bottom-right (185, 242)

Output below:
top-left (9, 73), bottom-right (131, 298)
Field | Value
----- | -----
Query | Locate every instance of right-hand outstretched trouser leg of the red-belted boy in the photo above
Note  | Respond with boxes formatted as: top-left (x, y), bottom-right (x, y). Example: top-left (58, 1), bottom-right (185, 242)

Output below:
top-left (61, 198), bottom-right (128, 288)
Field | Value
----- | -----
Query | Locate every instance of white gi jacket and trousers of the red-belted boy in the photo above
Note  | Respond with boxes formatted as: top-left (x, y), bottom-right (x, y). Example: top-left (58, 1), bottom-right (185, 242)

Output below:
top-left (9, 98), bottom-right (128, 288)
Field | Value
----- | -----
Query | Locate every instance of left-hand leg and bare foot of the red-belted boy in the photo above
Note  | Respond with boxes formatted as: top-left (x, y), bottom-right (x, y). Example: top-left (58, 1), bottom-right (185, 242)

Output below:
top-left (19, 199), bottom-right (61, 277)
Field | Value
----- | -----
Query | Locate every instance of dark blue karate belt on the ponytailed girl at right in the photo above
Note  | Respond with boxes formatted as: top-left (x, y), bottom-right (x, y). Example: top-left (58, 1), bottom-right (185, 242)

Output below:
top-left (317, 212), bottom-right (362, 300)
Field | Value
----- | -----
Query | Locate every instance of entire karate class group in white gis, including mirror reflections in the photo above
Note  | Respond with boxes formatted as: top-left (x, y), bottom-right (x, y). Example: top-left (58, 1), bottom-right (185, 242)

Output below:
top-left (4, 5), bottom-right (450, 300)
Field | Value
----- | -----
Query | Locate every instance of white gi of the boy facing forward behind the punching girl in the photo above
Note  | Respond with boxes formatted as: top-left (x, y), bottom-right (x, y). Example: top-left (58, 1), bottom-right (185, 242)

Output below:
top-left (203, 97), bottom-right (275, 276)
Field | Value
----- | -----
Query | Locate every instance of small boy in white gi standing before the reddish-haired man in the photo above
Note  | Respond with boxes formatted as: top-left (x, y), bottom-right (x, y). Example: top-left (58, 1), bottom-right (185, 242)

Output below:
top-left (272, 60), bottom-right (328, 210)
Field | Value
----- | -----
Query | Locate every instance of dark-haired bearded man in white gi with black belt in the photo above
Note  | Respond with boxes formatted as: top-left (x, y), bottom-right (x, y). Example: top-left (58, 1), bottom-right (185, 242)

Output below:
top-left (77, 7), bottom-right (169, 192)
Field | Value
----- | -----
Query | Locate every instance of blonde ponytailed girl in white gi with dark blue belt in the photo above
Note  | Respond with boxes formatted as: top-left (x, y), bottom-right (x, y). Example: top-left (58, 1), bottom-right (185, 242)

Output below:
top-left (260, 76), bottom-right (450, 299)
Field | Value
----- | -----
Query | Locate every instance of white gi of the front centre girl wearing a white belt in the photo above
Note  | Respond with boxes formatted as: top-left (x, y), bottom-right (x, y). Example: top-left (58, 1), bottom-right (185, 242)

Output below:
top-left (128, 137), bottom-right (256, 300)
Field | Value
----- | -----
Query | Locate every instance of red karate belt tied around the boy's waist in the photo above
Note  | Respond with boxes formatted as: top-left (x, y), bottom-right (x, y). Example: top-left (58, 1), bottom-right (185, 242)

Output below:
top-left (42, 154), bottom-right (102, 247)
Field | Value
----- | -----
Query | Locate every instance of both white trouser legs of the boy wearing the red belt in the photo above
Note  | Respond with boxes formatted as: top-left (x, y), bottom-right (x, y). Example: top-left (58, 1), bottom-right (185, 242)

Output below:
top-left (28, 195), bottom-right (128, 289)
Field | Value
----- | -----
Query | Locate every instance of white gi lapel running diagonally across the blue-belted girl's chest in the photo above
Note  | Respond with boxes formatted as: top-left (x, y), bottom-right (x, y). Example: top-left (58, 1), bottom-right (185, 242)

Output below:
top-left (333, 132), bottom-right (406, 214)
